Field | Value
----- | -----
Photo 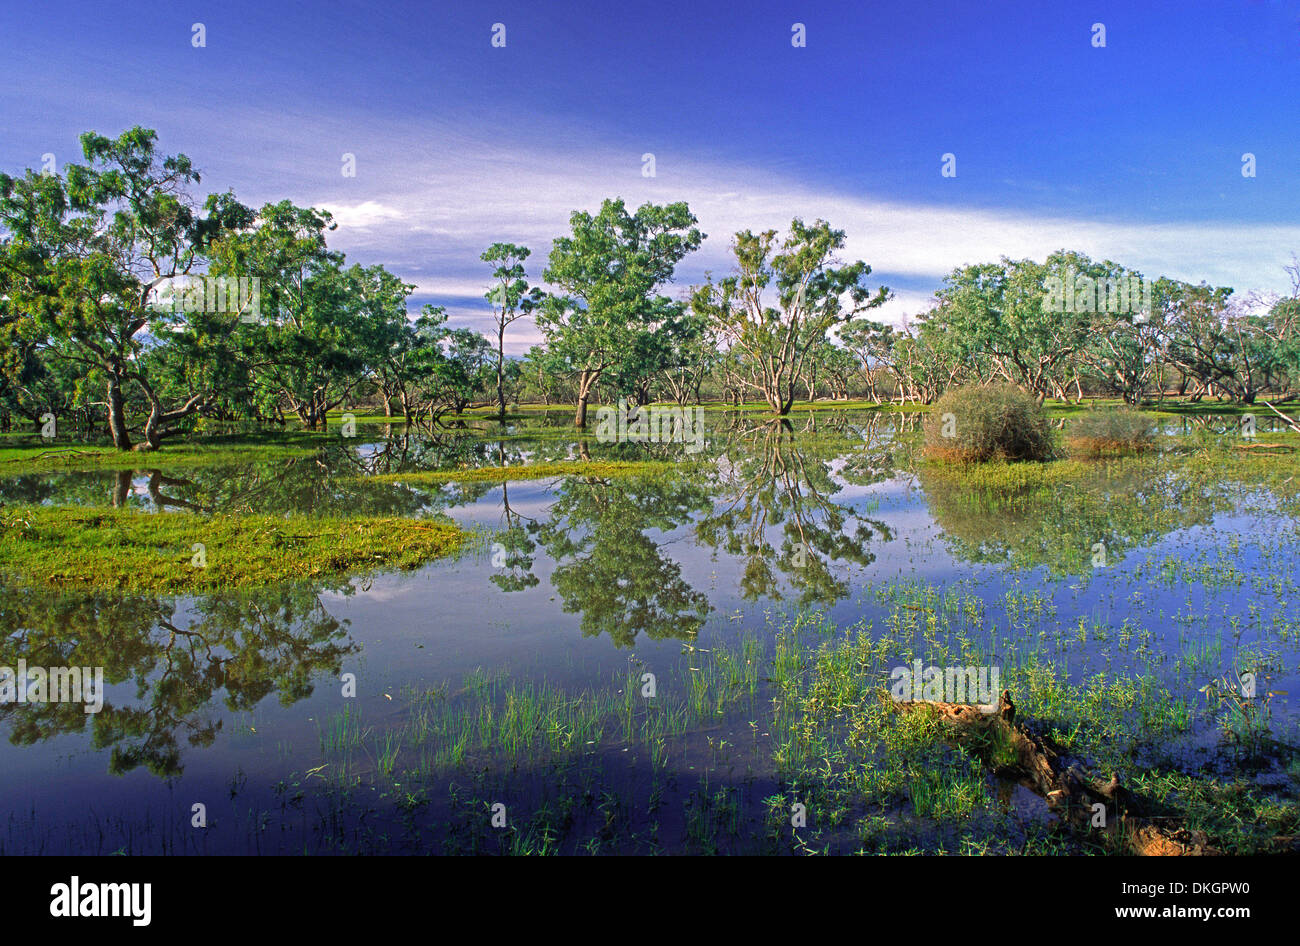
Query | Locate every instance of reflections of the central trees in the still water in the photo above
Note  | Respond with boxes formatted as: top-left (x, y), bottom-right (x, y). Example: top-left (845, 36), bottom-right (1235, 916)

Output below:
top-left (490, 413), bottom-right (894, 647)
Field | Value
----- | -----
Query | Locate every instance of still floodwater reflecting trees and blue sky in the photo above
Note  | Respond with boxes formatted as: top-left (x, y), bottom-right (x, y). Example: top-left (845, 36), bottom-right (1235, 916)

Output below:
top-left (0, 411), bottom-right (1300, 854)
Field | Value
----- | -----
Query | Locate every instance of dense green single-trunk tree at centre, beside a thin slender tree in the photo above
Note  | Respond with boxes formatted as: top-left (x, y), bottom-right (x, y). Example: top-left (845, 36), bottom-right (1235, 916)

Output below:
top-left (537, 199), bottom-right (703, 428)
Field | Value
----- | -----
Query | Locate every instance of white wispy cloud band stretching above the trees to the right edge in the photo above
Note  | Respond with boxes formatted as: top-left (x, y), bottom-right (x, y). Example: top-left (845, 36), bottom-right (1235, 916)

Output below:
top-left (295, 124), bottom-right (1300, 351)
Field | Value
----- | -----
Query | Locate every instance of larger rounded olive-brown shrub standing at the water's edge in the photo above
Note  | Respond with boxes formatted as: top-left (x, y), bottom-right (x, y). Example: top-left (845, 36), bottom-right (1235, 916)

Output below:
top-left (926, 385), bottom-right (1056, 463)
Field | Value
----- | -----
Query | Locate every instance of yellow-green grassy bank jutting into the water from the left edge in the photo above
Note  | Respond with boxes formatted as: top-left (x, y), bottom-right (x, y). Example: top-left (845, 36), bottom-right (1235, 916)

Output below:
top-left (0, 505), bottom-right (467, 591)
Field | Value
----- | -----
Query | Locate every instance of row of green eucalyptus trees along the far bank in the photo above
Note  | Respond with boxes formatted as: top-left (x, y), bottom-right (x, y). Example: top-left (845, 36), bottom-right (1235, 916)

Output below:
top-left (0, 127), bottom-right (1300, 450)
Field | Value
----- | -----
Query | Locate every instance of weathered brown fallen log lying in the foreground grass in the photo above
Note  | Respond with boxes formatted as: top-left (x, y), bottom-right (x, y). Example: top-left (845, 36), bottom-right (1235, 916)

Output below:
top-left (893, 690), bottom-right (1218, 856)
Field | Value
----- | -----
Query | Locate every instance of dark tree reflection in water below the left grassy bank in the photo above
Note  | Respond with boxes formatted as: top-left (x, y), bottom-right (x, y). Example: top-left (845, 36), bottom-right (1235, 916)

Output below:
top-left (0, 580), bottom-right (359, 777)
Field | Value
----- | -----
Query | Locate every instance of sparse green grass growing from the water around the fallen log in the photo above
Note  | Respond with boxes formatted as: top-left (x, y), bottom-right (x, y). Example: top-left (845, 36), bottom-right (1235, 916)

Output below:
top-left (295, 605), bottom-right (1300, 854)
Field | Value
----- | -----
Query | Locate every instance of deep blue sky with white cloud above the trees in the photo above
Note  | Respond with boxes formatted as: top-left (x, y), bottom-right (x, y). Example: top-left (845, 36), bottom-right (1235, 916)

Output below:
top-left (0, 0), bottom-right (1300, 351)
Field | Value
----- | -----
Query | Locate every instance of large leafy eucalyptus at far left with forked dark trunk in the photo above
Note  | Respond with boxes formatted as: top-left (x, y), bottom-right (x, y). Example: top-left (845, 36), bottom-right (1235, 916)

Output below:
top-left (0, 126), bottom-right (251, 450)
